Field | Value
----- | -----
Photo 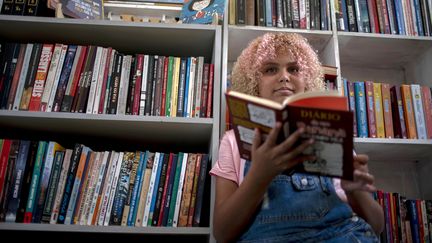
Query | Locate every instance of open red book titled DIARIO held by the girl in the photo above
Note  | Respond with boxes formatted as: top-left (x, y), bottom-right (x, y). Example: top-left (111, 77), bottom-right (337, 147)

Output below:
top-left (225, 91), bottom-right (353, 180)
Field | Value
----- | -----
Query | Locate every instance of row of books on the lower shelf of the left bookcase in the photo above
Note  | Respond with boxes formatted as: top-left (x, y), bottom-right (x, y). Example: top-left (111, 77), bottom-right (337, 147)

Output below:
top-left (0, 139), bottom-right (209, 227)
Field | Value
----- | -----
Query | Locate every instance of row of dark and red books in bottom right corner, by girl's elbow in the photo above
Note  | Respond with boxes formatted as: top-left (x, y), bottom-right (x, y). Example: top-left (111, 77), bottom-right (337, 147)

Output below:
top-left (374, 190), bottom-right (432, 243)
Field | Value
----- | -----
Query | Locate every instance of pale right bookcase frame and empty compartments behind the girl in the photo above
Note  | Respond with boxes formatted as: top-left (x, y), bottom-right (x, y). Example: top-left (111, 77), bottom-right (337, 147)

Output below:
top-left (221, 1), bottom-right (432, 206)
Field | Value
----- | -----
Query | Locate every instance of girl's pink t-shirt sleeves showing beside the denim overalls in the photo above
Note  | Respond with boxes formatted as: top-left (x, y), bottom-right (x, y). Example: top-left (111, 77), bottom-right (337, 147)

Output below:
top-left (210, 130), bottom-right (347, 202)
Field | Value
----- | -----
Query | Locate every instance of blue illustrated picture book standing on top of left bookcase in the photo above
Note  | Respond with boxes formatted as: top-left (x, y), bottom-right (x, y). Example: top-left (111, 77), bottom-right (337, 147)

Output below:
top-left (180, 0), bottom-right (225, 24)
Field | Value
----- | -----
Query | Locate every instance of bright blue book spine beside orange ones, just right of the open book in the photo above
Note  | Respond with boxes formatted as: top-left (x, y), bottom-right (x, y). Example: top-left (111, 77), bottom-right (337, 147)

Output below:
top-left (354, 82), bottom-right (368, 138)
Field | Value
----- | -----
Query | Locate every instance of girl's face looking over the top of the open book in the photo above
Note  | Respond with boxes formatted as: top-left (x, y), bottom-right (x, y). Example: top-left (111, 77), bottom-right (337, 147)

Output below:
top-left (258, 55), bottom-right (306, 103)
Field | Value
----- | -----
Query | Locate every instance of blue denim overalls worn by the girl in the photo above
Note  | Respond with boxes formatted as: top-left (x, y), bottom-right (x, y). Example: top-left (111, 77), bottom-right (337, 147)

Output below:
top-left (239, 161), bottom-right (378, 243)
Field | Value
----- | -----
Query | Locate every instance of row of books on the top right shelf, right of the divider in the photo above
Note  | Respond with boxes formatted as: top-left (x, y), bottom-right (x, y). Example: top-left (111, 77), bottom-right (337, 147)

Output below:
top-left (335, 0), bottom-right (432, 36)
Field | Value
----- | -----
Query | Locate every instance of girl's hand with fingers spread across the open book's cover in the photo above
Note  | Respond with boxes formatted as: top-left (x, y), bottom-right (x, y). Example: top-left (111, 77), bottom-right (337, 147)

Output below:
top-left (250, 122), bottom-right (314, 182)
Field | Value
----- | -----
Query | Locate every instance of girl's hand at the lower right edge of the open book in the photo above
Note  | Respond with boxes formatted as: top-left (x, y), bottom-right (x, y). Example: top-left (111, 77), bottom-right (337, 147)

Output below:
top-left (341, 154), bottom-right (376, 193)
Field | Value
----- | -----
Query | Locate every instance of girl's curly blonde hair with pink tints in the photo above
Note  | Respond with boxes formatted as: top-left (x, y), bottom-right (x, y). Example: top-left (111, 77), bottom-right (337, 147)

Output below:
top-left (231, 33), bottom-right (324, 96)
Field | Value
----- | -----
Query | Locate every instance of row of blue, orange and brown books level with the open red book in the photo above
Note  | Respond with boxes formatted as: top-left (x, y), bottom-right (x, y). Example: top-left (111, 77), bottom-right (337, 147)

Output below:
top-left (343, 79), bottom-right (432, 139)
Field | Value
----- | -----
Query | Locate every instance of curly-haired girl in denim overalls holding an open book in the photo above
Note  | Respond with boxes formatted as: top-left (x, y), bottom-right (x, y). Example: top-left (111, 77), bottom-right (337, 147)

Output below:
top-left (210, 33), bottom-right (384, 242)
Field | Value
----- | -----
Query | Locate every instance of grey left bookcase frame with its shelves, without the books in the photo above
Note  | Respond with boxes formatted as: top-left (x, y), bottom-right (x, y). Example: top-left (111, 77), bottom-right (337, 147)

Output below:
top-left (0, 15), bottom-right (222, 242)
